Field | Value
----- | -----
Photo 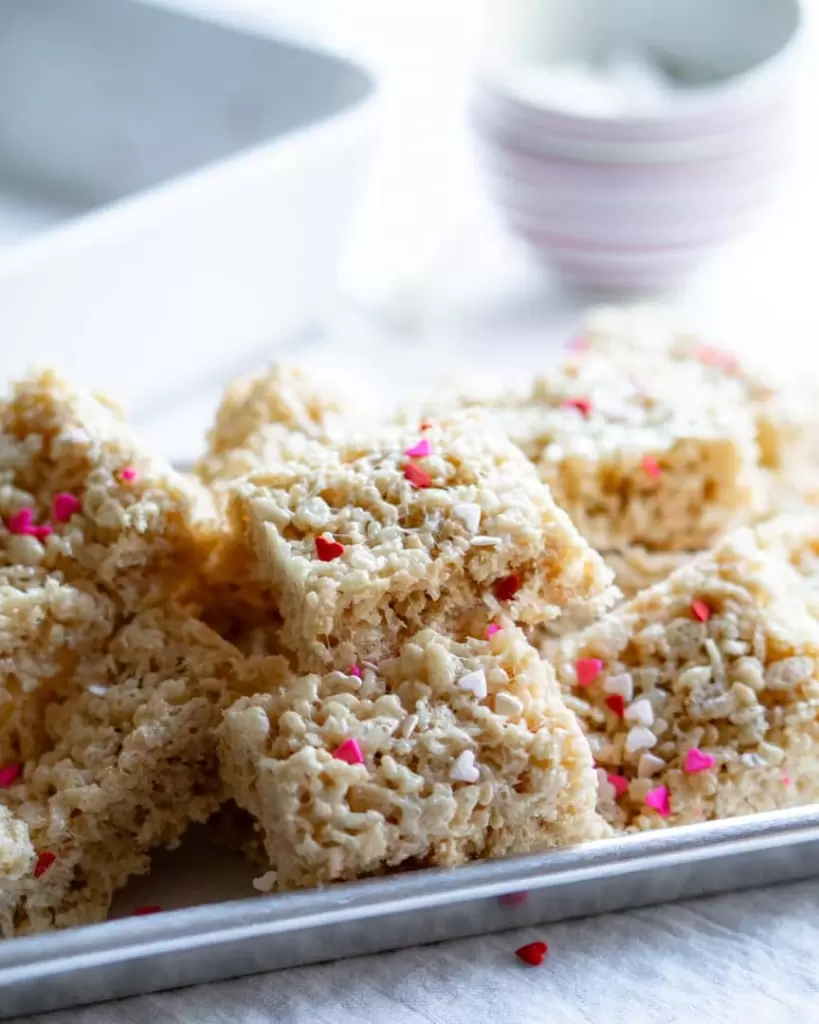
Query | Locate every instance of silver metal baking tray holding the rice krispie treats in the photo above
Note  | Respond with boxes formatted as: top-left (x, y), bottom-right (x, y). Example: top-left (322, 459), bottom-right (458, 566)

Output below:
top-left (0, 807), bottom-right (819, 1019)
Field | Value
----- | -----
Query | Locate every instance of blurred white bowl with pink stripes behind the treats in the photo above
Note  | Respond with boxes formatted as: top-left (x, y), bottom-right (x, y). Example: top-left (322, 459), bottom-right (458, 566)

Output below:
top-left (471, 0), bottom-right (805, 293)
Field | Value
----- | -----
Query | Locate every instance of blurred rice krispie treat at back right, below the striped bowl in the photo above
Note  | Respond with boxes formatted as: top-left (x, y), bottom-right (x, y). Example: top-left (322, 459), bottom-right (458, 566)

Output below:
top-left (405, 350), bottom-right (765, 552)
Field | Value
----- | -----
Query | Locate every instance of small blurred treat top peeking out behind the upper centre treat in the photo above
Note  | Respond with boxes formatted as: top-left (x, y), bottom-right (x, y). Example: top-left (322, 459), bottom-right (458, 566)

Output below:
top-left (197, 364), bottom-right (340, 483)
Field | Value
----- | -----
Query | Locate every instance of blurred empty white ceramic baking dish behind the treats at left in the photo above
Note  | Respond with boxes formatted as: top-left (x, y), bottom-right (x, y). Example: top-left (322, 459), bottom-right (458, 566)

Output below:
top-left (0, 0), bottom-right (377, 444)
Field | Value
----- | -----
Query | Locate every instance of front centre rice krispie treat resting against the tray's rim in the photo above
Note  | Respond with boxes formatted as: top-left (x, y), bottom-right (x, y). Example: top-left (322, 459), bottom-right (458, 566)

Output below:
top-left (220, 628), bottom-right (605, 890)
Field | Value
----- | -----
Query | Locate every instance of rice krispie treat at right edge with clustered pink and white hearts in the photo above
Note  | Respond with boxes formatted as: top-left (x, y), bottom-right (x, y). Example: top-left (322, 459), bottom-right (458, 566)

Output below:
top-left (557, 530), bottom-right (819, 829)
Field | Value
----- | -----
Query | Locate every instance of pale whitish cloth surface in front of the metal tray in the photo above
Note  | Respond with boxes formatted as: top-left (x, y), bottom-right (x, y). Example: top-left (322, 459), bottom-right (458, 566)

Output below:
top-left (15, 882), bottom-right (819, 1024)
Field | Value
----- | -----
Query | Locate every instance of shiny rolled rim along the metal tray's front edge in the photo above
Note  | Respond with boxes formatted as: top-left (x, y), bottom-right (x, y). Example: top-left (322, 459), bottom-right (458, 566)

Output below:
top-left (0, 805), bottom-right (819, 978)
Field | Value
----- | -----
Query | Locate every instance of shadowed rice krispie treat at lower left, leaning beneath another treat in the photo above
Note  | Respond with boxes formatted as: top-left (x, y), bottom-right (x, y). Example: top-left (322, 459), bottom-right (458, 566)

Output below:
top-left (0, 610), bottom-right (246, 936)
